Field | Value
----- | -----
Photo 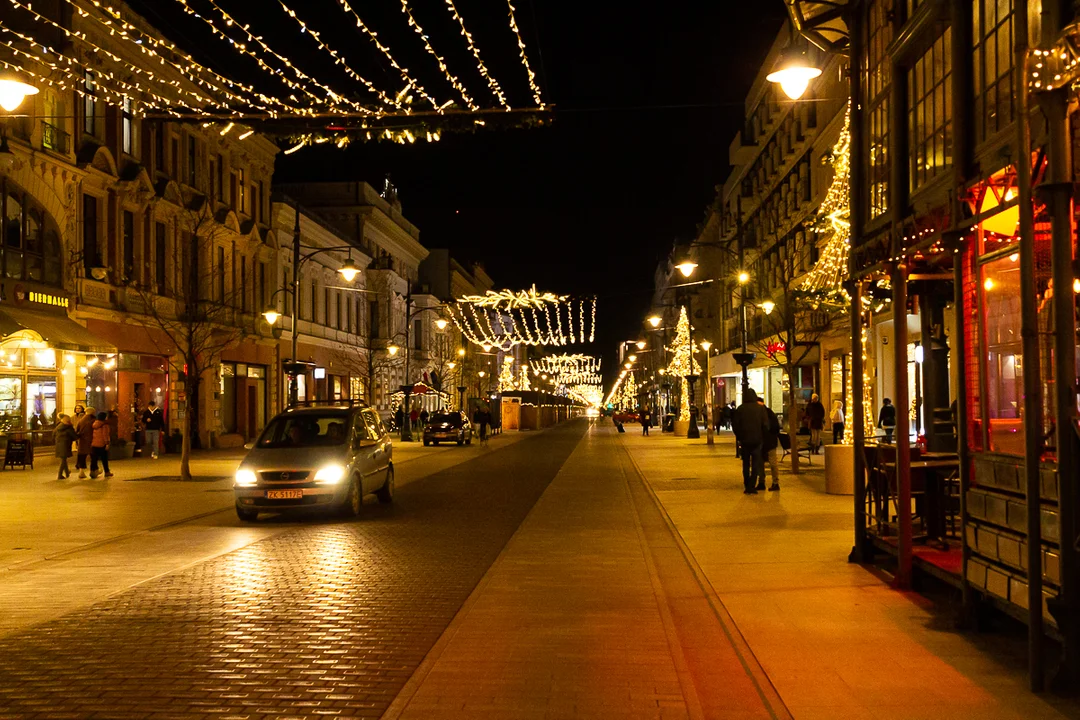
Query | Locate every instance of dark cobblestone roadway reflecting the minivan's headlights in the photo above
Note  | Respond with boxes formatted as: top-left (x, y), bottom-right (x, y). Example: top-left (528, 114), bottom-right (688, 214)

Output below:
top-left (0, 422), bottom-right (586, 718)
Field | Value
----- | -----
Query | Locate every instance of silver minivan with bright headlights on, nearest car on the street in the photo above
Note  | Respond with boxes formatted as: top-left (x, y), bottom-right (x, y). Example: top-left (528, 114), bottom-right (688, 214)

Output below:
top-left (233, 405), bottom-right (394, 521)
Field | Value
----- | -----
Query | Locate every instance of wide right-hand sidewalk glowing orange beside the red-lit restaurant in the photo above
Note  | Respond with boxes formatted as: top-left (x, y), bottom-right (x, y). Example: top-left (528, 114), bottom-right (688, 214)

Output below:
top-left (612, 431), bottom-right (1080, 720)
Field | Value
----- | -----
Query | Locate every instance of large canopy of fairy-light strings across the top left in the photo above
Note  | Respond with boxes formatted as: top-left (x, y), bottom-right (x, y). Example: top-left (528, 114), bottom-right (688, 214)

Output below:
top-left (0, 0), bottom-right (548, 144)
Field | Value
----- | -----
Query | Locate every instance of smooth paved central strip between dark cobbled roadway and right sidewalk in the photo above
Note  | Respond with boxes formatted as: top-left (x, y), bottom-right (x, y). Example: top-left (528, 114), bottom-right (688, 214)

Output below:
top-left (384, 418), bottom-right (789, 720)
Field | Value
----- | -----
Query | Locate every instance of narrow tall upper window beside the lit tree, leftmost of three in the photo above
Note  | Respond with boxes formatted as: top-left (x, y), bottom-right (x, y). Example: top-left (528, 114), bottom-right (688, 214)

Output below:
top-left (863, 0), bottom-right (892, 219)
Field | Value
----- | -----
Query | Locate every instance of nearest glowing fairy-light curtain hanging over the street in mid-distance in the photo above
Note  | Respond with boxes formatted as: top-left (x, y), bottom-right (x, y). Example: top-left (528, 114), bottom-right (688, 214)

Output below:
top-left (447, 287), bottom-right (596, 351)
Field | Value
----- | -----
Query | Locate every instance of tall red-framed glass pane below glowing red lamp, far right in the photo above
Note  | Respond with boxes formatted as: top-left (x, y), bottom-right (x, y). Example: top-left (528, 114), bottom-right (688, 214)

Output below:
top-left (980, 255), bottom-right (1024, 456)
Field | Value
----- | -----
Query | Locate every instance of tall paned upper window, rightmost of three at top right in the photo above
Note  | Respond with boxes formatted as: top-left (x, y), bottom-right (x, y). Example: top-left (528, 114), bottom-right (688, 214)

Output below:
top-left (971, 0), bottom-right (1015, 146)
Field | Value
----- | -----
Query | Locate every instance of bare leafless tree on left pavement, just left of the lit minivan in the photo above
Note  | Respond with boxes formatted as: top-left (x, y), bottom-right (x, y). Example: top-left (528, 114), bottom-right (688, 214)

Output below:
top-left (131, 199), bottom-right (254, 480)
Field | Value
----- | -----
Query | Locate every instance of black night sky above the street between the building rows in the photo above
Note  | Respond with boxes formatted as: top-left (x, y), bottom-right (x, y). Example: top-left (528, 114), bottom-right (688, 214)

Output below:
top-left (132, 0), bottom-right (784, 382)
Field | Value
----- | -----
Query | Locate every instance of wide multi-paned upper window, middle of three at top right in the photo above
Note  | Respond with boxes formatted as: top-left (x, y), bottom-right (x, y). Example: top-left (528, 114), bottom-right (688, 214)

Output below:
top-left (907, 28), bottom-right (953, 192)
